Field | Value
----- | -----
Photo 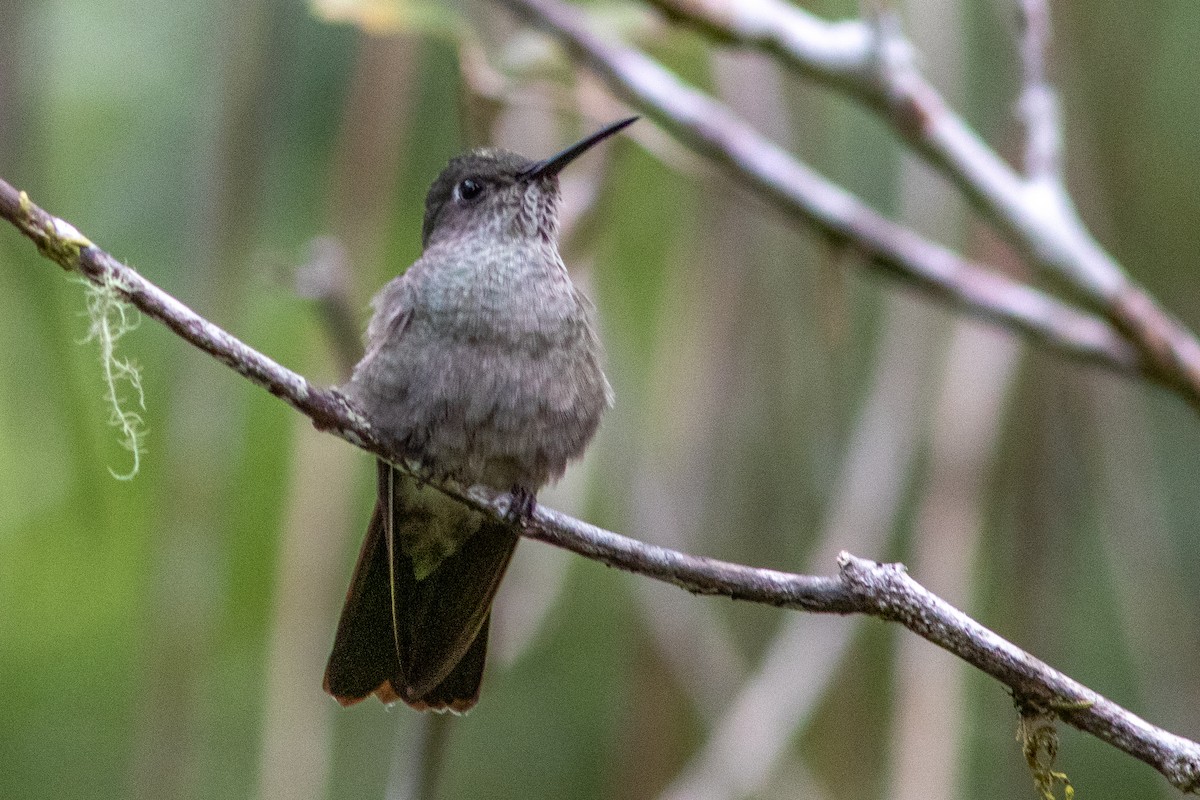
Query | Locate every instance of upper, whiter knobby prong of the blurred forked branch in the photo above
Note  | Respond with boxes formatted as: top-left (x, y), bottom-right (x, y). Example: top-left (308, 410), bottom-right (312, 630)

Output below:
top-left (649, 0), bottom-right (1113, 293)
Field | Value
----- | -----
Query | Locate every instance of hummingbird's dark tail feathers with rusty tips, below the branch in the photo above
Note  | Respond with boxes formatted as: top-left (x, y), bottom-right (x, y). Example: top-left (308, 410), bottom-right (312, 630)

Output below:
top-left (325, 461), bottom-right (518, 712)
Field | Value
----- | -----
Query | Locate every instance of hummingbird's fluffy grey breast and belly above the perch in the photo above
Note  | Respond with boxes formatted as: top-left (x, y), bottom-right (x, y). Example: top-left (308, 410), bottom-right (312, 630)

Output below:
top-left (346, 243), bottom-right (612, 491)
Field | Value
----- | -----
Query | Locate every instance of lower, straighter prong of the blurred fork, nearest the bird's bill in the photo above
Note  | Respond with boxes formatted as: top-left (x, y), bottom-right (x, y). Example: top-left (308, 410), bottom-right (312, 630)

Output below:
top-left (487, 0), bottom-right (1200, 405)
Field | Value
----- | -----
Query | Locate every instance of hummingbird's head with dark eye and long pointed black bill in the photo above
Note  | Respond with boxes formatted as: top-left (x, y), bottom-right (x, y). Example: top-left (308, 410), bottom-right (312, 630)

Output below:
top-left (421, 116), bottom-right (637, 247)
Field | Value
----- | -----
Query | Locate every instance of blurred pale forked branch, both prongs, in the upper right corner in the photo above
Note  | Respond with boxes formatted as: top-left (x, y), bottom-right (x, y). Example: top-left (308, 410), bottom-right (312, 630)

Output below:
top-left (496, 0), bottom-right (1200, 408)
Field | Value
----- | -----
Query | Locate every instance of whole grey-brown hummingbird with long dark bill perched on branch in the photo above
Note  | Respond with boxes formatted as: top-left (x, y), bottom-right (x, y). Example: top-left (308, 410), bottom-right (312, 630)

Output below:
top-left (324, 116), bottom-right (637, 714)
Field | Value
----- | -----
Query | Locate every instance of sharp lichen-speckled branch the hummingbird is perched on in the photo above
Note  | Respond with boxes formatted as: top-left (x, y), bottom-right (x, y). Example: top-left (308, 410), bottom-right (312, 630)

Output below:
top-left (0, 180), bottom-right (1200, 792)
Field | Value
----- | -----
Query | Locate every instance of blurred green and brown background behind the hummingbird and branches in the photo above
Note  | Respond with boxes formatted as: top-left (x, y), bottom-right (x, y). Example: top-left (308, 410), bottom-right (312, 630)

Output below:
top-left (0, 0), bottom-right (1200, 800)
